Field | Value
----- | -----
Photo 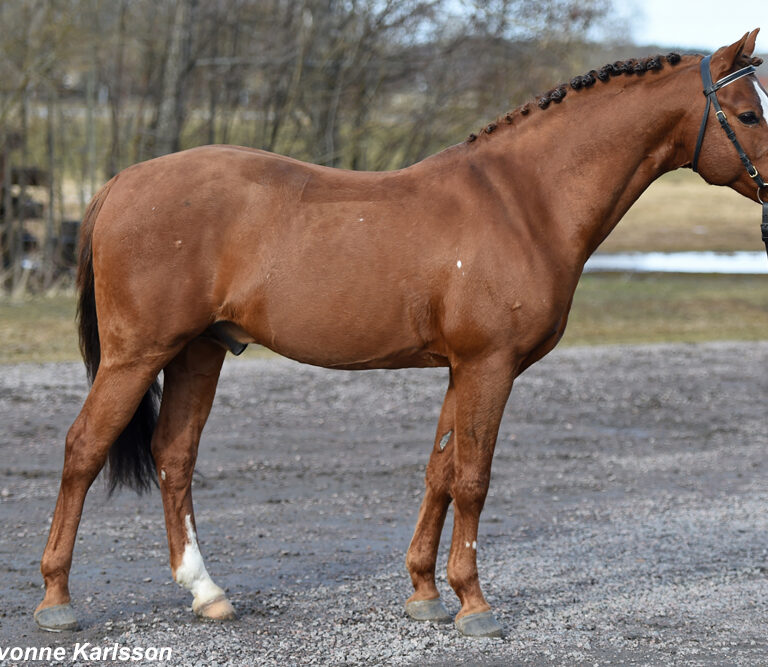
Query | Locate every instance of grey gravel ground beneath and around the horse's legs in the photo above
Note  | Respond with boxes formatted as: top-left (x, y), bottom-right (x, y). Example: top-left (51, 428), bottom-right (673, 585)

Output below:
top-left (0, 343), bottom-right (768, 665)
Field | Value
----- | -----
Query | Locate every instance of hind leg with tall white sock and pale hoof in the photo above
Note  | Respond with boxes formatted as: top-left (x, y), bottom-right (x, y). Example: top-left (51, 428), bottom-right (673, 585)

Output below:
top-left (152, 338), bottom-right (235, 619)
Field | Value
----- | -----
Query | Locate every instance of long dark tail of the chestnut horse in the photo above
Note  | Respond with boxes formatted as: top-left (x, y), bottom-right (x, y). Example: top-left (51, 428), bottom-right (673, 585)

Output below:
top-left (77, 179), bottom-right (162, 495)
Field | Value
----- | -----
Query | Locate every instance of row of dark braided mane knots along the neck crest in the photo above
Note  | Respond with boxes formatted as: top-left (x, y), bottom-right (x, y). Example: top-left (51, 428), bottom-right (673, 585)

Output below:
top-left (466, 53), bottom-right (682, 143)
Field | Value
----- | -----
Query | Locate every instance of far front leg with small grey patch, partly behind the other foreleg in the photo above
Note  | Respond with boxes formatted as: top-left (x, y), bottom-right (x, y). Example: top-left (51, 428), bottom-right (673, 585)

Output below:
top-left (405, 376), bottom-right (455, 622)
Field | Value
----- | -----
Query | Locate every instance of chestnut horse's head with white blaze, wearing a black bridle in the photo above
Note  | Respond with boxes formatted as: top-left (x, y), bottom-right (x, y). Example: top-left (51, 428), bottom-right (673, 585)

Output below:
top-left (693, 28), bottom-right (768, 201)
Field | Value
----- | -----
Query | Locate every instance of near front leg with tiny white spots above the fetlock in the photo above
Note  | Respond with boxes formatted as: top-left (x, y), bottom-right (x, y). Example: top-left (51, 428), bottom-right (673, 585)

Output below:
top-left (448, 355), bottom-right (516, 637)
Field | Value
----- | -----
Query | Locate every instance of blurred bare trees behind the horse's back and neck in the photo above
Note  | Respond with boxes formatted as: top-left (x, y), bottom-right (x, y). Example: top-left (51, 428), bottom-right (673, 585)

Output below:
top-left (0, 0), bottom-right (638, 293)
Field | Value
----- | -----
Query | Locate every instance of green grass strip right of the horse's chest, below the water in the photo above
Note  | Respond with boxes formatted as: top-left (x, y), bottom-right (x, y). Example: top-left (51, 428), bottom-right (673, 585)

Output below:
top-left (563, 274), bottom-right (768, 345)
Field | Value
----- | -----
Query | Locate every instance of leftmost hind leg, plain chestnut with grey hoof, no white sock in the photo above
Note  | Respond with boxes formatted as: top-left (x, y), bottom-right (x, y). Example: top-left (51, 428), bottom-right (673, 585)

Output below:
top-left (35, 360), bottom-right (164, 632)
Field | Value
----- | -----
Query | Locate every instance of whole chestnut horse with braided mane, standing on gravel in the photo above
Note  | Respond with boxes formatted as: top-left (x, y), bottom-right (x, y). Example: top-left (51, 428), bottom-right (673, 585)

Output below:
top-left (35, 30), bottom-right (768, 636)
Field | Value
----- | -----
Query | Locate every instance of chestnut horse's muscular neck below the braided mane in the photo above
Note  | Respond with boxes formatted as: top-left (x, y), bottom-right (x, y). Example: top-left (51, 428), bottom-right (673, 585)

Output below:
top-left (468, 65), bottom-right (696, 264)
